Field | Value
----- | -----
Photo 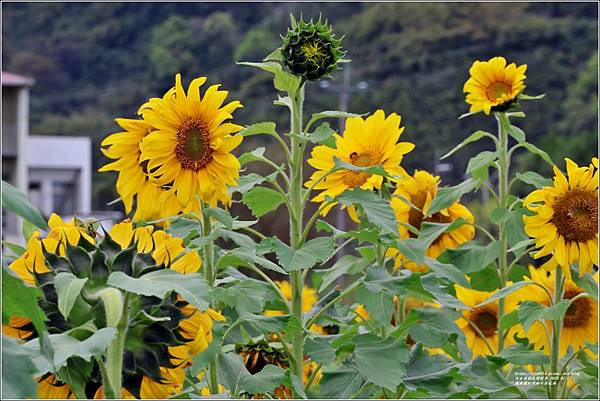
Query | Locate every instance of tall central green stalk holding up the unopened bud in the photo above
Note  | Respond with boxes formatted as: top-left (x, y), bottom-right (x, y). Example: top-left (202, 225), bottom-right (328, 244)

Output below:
top-left (288, 85), bottom-right (306, 377)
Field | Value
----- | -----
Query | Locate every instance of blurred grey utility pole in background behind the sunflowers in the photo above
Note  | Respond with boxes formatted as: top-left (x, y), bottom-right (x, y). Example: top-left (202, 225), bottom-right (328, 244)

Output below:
top-left (319, 64), bottom-right (369, 260)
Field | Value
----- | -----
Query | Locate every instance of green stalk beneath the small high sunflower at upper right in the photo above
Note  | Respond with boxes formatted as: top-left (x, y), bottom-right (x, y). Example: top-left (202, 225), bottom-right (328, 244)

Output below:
top-left (496, 113), bottom-right (510, 352)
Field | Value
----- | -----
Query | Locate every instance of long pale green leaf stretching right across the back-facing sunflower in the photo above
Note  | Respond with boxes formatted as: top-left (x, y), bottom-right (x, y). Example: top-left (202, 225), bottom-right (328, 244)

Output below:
top-left (107, 269), bottom-right (209, 311)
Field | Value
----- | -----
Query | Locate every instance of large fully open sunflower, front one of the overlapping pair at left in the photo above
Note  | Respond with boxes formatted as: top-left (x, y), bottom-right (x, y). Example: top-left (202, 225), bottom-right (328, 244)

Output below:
top-left (139, 74), bottom-right (242, 207)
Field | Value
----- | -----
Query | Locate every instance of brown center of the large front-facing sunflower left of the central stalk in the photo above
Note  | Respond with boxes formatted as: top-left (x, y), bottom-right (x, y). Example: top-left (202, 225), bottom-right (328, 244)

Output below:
top-left (175, 118), bottom-right (212, 171)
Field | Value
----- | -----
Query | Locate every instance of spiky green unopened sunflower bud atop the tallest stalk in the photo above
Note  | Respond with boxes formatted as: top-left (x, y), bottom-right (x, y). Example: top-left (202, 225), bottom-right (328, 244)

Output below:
top-left (281, 16), bottom-right (346, 81)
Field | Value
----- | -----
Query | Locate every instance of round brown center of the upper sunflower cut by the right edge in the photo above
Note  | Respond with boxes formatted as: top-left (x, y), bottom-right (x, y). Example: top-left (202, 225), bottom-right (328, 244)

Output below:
top-left (552, 189), bottom-right (598, 242)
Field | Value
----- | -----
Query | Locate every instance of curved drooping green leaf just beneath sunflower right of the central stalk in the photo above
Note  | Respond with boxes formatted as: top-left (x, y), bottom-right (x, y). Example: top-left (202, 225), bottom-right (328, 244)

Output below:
top-left (337, 188), bottom-right (398, 233)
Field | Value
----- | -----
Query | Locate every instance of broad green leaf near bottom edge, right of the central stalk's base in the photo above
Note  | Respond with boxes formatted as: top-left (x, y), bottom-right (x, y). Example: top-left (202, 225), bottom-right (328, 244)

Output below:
top-left (353, 334), bottom-right (408, 391)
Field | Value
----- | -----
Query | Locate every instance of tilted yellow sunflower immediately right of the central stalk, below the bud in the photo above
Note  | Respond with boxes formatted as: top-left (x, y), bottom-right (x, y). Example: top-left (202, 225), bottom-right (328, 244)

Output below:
top-left (305, 110), bottom-right (415, 219)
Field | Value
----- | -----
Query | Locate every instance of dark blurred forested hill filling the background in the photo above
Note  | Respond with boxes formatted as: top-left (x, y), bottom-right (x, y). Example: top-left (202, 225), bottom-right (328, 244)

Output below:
top-left (2, 3), bottom-right (598, 209)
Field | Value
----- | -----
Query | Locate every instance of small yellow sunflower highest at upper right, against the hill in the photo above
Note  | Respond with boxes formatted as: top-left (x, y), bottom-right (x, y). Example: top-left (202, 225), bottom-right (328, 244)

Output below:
top-left (463, 57), bottom-right (527, 115)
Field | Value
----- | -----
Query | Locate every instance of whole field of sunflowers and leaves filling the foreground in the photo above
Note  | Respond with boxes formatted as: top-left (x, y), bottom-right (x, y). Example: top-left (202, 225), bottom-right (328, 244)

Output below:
top-left (2, 16), bottom-right (598, 399)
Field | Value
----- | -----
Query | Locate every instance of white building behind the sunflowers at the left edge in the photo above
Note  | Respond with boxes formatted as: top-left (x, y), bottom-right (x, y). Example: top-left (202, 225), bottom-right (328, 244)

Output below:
top-left (2, 71), bottom-right (120, 243)
